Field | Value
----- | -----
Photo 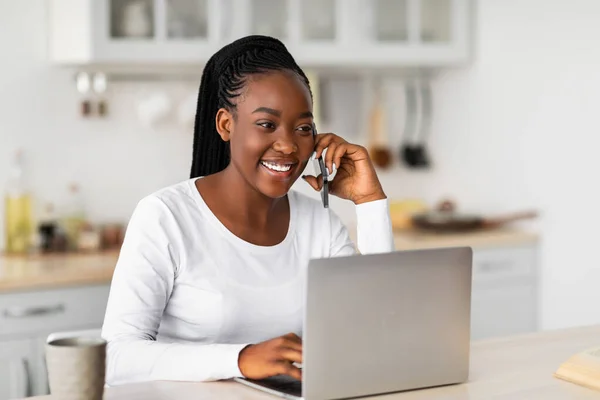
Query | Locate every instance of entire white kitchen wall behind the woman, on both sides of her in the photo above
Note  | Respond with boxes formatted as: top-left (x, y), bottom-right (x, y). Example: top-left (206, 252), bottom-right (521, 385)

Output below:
top-left (0, 0), bottom-right (600, 328)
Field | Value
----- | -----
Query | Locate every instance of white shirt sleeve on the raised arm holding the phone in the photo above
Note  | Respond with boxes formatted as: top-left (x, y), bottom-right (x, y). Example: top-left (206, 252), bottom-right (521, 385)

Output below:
top-left (330, 198), bottom-right (394, 257)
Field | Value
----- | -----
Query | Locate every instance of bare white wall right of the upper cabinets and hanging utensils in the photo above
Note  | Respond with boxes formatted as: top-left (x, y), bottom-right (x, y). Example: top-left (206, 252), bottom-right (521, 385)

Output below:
top-left (426, 0), bottom-right (600, 328)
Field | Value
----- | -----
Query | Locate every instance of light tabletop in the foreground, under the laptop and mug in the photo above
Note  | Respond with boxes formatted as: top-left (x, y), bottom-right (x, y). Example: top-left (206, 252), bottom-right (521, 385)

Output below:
top-left (28, 326), bottom-right (600, 400)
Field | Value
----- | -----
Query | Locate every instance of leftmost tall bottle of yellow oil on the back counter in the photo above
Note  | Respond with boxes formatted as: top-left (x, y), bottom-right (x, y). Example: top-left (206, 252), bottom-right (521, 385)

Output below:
top-left (4, 149), bottom-right (35, 254)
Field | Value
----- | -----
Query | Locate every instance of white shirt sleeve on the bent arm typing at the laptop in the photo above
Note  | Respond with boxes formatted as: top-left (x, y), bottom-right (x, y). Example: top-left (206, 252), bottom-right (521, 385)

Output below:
top-left (102, 198), bottom-right (246, 385)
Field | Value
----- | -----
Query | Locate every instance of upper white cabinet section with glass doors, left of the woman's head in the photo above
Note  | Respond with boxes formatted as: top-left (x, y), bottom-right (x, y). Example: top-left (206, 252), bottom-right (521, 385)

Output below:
top-left (49, 0), bottom-right (221, 65)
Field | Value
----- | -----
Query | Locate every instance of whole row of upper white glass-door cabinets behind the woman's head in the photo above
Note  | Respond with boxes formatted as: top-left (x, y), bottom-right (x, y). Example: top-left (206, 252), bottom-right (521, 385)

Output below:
top-left (49, 0), bottom-right (471, 69)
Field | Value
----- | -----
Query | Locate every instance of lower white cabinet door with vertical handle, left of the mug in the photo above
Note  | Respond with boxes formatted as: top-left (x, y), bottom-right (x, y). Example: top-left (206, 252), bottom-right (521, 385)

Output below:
top-left (0, 340), bottom-right (35, 400)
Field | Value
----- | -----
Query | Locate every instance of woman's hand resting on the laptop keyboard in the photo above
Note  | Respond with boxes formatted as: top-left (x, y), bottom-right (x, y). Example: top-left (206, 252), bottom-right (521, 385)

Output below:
top-left (238, 333), bottom-right (302, 379)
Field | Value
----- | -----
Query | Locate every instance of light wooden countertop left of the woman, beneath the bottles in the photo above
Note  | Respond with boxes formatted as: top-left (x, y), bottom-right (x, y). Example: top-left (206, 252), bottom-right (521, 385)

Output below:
top-left (0, 251), bottom-right (118, 293)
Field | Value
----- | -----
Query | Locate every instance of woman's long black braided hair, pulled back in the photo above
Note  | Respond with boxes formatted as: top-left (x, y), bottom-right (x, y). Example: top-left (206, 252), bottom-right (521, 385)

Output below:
top-left (191, 35), bottom-right (312, 178)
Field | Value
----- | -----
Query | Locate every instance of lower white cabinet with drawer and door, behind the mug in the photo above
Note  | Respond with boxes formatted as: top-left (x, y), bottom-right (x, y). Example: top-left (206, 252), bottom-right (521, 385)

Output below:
top-left (0, 284), bottom-right (110, 400)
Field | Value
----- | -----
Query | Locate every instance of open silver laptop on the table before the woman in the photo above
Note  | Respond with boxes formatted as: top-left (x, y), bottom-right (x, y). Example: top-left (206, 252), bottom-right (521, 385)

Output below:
top-left (236, 247), bottom-right (473, 400)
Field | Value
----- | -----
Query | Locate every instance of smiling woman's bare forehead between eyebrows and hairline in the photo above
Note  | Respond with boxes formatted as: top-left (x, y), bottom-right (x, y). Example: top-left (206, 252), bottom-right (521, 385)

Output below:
top-left (237, 71), bottom-right (312, 113)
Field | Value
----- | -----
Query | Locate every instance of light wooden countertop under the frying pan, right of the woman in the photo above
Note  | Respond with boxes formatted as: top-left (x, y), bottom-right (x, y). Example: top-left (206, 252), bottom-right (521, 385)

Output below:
top-left (394, 229), bottom-right (539, 250)
